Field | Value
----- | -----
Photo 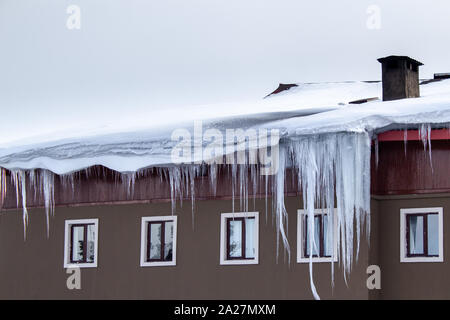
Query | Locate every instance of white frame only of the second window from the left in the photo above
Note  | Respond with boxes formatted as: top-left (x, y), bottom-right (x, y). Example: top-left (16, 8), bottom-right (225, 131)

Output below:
top-left (140, 215), bottom-right (178, 267)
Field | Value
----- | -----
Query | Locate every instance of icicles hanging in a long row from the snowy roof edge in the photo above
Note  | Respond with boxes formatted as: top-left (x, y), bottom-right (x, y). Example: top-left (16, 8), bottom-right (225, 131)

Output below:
top-left (0, 127), bottom-right (424, 299)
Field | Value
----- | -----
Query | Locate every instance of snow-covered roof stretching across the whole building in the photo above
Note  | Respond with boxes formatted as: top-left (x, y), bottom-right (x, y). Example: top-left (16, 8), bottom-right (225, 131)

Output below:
top-left (0, 80), bottom-right (450, 174)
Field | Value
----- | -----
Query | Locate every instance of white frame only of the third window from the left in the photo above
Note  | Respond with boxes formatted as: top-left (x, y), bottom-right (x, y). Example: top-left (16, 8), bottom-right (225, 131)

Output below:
top-left (220, 212), bottom-right (259, 265)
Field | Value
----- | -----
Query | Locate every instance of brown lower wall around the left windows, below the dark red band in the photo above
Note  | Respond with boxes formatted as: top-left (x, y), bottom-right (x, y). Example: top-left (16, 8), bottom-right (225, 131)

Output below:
top-left (0, 197), bottom-right (369, 299)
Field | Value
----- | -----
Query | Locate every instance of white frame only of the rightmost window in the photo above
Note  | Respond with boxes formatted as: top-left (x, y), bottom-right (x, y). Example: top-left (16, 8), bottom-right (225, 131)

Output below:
top-left (400, 207), bottom-right (444, 262)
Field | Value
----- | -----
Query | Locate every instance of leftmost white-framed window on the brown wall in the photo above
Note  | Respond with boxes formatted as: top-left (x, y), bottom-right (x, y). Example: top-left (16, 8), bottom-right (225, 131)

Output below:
top-left (64, 219), bottom-right (98, 268)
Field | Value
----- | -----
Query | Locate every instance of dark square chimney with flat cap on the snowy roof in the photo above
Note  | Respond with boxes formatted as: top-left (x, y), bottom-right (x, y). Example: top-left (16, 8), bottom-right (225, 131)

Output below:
top-left (378, 56), bottom-right (423, 101)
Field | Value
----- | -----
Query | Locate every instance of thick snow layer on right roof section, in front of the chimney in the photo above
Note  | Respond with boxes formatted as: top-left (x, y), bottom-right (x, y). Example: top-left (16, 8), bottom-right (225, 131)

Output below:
top-left (270, 80), bottom-right (450, 136)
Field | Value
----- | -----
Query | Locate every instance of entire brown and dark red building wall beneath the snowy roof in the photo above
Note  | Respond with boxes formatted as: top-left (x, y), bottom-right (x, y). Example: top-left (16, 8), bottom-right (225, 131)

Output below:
top-left (0, 134), bottom-right (450, 299)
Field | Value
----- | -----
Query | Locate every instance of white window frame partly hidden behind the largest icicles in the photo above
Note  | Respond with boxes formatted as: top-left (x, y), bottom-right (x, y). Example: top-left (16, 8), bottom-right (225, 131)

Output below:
top-left (297, 209), bottom-right (338, 263)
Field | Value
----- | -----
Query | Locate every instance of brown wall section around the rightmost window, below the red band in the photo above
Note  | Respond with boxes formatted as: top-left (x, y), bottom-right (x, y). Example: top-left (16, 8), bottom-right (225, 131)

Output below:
top-left (378, 194), bottom-right (450, 299)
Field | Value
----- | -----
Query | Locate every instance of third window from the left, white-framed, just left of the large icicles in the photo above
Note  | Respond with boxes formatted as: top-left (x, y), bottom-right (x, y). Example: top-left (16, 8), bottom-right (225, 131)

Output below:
top-left (220, 212), bottom-right (259, 264)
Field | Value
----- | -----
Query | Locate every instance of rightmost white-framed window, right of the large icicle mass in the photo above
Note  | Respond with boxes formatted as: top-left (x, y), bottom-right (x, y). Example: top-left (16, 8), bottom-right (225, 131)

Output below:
top-left (400, 208), bottom-right (444, 262)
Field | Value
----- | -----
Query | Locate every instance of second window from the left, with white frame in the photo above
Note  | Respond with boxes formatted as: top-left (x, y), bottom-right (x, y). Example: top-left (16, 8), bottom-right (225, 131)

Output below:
top-left (141, 216), bottom-right (177, 267)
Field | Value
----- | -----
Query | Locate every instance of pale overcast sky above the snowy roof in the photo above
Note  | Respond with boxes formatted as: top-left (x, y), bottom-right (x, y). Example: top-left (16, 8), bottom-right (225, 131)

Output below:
top-left (0, 0), bottom-right (450, 140)
